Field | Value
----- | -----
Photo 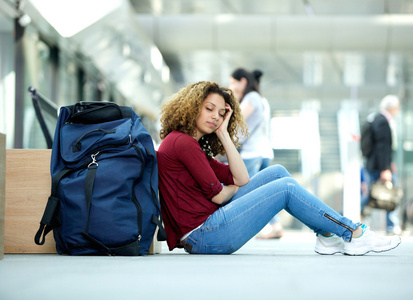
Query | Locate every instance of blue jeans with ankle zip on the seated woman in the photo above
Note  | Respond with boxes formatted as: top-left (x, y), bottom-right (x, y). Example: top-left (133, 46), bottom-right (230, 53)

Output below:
top-left (185, 165), bottom-right (360, 254)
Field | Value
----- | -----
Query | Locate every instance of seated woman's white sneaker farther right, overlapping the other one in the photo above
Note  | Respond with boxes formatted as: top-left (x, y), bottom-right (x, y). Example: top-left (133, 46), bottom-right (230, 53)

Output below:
top-left (343, 224), bottom-right (401, 255)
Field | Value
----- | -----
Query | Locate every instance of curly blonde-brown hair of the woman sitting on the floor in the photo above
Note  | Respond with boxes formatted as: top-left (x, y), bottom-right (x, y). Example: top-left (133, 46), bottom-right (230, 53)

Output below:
top-left (159, 81), bottom-right (248, 156)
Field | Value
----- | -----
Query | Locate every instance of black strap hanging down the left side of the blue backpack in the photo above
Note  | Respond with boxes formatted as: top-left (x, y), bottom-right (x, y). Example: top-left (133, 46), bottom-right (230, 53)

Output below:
top-left (34, 168), bottom-right (76, 245)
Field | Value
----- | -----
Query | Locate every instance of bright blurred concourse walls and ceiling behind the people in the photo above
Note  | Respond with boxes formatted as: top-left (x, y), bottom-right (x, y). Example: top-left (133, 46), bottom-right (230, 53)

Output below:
top-left (0, 0), bottom-right (413, 230)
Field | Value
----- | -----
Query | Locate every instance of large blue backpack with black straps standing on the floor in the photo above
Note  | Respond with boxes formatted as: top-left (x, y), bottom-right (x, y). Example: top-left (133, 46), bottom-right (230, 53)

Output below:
top-left (35, 102), bottom-right (166, 255)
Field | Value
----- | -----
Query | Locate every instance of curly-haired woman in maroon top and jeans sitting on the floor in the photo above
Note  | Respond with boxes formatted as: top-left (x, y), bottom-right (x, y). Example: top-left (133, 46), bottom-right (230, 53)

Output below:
top-left (158, 81), bottom-right (401, 255)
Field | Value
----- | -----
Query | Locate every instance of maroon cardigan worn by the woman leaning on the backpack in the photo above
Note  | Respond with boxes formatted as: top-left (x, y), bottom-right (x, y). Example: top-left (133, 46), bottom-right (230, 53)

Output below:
top-left (157, 131), bottom-right (234, 250)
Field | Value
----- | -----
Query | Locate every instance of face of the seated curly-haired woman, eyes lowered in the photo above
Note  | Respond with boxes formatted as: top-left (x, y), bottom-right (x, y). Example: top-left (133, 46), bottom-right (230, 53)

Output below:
top-left (196, 94), bottom-right (226, 140)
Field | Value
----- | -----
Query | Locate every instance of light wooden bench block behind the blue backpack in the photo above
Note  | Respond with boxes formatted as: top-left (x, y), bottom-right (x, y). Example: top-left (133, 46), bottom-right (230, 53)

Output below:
top-left (4, 149), bottom-right (161, 254)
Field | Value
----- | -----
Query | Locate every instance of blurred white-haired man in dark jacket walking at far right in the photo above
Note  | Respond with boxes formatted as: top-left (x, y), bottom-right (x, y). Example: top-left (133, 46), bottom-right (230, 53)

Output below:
top-left (366, 95), bottom-right (400, 234)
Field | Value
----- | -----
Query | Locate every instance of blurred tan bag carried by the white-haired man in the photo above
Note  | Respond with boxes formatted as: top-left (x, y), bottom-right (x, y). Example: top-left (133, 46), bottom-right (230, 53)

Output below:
top-left (368, 180), bottom-right (403, 211)
